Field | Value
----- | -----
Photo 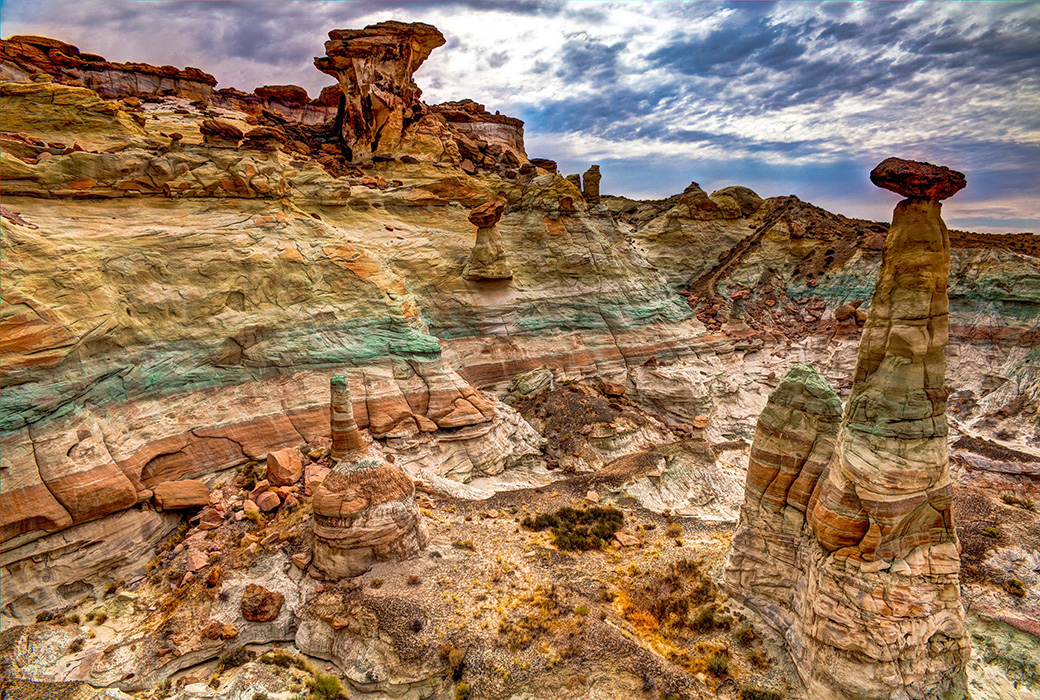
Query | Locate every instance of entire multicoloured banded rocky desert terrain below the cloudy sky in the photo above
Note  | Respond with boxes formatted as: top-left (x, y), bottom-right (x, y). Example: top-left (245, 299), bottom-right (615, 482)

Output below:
top-left (0, 17), bottom-right (1040, 700)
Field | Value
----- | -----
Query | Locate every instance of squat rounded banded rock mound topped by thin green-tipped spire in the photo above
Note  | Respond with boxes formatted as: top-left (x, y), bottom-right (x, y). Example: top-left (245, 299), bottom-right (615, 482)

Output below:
top-left (313, 377), bottom-right (427, 580)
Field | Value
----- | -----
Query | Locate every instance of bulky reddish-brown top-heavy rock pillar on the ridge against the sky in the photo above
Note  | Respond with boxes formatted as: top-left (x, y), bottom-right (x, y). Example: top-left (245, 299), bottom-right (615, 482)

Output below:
top-left (314, 22), bottom-right (444, 160)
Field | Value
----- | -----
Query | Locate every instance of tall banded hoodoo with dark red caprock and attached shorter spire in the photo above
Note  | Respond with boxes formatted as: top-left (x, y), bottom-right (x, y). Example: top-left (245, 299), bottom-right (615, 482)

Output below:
top-left (726, 161), bottom-right (969, 700)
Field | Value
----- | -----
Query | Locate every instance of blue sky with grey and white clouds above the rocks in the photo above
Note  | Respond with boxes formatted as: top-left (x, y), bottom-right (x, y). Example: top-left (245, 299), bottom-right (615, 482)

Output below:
top-left (6, 0), bottom-right (1040, 233)
